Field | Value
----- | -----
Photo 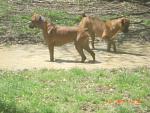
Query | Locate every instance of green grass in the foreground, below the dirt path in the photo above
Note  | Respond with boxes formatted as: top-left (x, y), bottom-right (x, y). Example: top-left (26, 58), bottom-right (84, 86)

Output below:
top-left (0, 68), bottom-right (150, 113)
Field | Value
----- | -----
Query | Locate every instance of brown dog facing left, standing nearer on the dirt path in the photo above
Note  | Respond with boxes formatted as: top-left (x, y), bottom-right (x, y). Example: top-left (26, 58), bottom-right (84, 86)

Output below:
top-left (29, 14), bottom-right (95, 62)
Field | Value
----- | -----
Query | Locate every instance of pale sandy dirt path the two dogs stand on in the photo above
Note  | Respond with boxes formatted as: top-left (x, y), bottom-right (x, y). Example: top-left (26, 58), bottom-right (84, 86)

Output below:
top-left (0, 42), bottom-right (150, 70)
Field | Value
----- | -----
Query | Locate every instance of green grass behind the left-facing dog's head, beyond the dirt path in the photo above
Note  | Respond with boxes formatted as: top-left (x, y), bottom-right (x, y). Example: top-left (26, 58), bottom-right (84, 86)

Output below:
top-left (0, 0), bottom-right (80, 39)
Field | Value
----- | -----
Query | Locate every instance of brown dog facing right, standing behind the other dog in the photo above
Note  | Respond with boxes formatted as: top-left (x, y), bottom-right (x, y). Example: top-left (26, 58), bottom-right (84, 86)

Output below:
top-left (79, 14), bottom-right (130, 52)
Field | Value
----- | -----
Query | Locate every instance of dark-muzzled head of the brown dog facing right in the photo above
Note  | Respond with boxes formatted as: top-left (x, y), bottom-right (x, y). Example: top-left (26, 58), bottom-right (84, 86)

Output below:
top-left (120, 18), bottom-right (130, 33)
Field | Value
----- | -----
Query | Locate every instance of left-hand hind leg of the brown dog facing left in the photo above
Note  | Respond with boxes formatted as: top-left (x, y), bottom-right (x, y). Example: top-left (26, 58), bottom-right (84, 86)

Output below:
top-left (75, 42), bottom-right (86, 63)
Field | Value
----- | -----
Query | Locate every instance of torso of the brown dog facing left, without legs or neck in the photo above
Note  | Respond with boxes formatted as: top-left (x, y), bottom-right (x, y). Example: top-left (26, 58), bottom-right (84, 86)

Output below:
top-left (49, 25), bottom-right (89, 46)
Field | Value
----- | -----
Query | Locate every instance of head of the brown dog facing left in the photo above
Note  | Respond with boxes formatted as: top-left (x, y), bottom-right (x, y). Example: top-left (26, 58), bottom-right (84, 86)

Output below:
top-left (29, 14), bottom-right (46, 28)
